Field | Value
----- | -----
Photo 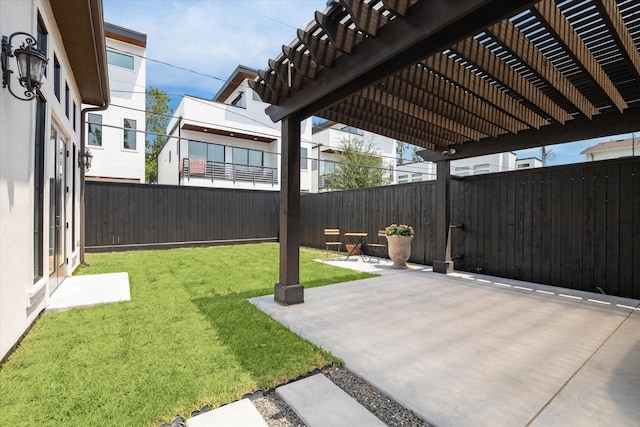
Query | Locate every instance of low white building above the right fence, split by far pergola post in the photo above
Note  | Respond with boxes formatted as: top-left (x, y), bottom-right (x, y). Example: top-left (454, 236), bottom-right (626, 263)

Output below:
top-left (394, 152), bottom-right (520, 184)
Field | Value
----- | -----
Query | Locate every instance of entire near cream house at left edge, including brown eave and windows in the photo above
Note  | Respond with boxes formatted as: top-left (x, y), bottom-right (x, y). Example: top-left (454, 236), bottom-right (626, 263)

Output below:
top-left (0, 0), bottom-right (109, 359)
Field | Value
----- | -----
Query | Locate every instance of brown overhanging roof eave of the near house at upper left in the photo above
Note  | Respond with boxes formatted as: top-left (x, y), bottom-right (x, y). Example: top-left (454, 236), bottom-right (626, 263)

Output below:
top-left (51, 0), bottom-right (111, 106)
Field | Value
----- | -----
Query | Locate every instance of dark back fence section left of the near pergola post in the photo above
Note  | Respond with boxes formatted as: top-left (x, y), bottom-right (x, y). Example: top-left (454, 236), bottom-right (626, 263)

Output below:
top-left (85, 182), bottom-right (279, 252)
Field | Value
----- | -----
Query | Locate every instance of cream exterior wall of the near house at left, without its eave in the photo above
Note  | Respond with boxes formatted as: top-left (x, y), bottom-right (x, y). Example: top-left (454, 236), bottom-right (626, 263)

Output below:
top-left (0, 0), bottom-right (87, 359)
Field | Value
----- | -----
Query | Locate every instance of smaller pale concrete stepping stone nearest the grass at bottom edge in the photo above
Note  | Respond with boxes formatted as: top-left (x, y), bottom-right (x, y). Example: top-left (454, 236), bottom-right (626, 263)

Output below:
top-left (187, 399), bottom-right (268, 427)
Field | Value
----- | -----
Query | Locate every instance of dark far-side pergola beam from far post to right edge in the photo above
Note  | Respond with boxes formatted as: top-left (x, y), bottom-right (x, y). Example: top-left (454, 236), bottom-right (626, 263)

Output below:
top-left (418, 107), bottom-right (640, 162)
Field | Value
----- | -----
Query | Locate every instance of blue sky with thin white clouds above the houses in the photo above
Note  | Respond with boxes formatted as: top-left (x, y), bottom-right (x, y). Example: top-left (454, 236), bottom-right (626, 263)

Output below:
top-left (103, 0), bottom-right (640, 166)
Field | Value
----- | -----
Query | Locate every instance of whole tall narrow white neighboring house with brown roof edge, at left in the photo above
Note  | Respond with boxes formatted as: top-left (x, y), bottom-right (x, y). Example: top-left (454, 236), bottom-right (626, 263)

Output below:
top-left (87, 23), bottom-right (147, 183)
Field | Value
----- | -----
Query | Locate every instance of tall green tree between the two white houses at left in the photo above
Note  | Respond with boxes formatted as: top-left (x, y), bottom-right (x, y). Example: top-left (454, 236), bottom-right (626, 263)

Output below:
top-left (145, 86), bottom-right (173, 183)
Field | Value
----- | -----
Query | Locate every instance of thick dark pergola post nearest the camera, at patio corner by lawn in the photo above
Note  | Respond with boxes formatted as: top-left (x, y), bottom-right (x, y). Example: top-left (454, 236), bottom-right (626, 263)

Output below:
top-left (274, 115), bottom-right (304, 305)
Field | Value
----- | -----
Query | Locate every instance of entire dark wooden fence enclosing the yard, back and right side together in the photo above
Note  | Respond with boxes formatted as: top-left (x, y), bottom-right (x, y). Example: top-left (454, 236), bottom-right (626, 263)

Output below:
top-left (86, 158), bottom-right (640, 298)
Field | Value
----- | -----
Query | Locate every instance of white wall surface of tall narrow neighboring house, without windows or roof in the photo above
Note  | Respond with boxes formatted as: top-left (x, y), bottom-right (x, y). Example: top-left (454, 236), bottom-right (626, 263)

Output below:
top-left (86, 29), bottom-right (146, 182)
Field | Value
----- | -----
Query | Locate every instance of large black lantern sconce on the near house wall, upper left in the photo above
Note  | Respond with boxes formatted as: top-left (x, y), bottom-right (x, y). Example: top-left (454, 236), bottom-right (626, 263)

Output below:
top-left (2, 32), bottom-right (49, 101)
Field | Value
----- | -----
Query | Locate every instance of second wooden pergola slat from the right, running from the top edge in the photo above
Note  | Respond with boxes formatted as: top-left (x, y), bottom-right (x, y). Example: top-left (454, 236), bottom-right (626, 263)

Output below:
top-left (533, 0), bottom-right (627, 111)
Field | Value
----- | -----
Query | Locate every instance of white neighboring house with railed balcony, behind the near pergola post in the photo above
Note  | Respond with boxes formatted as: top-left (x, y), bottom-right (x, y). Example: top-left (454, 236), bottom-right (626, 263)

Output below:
top-left (158, 65), bottom-right (312, 192)
